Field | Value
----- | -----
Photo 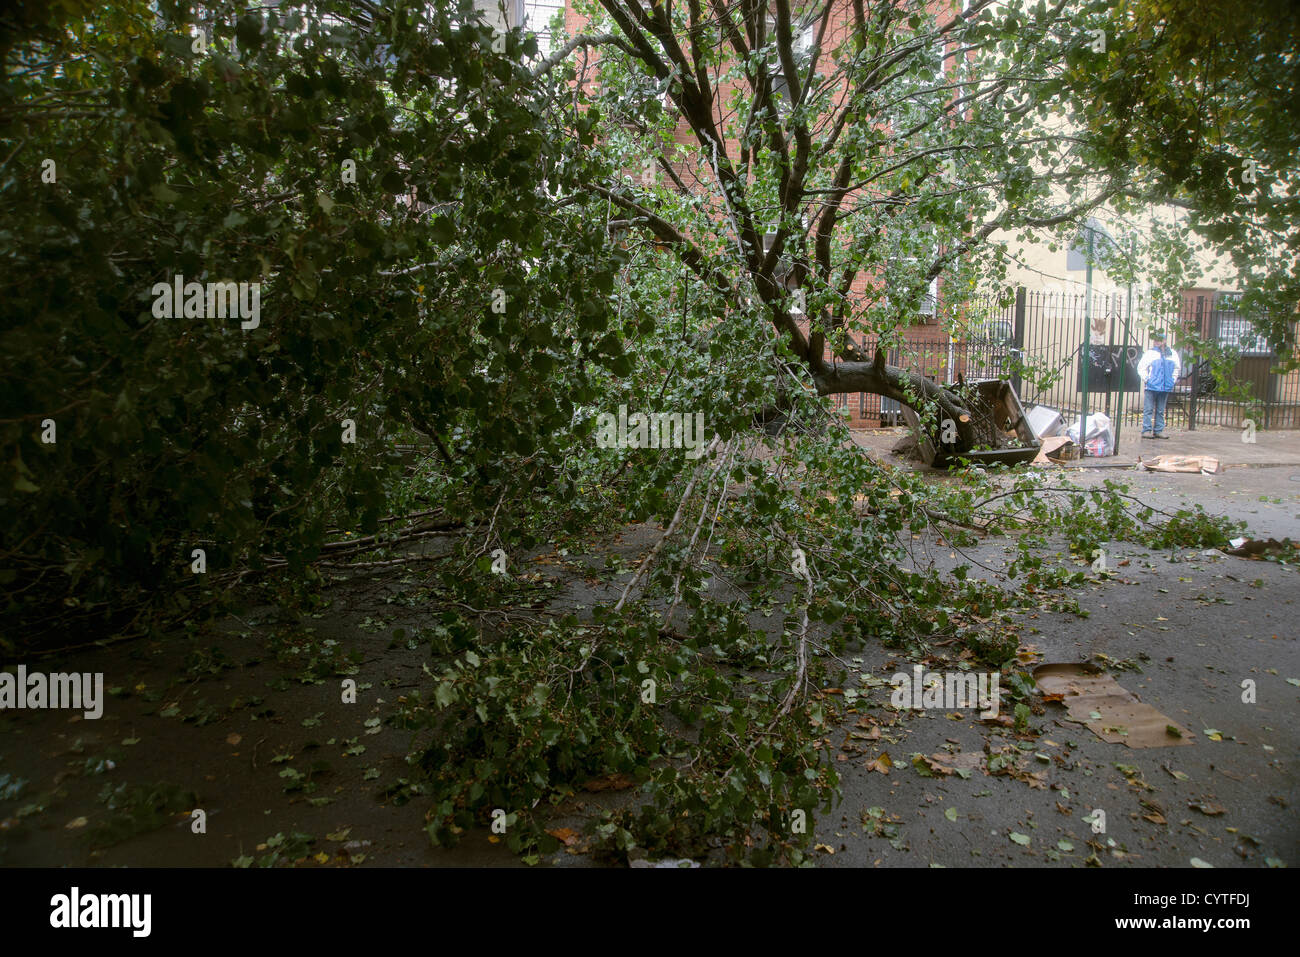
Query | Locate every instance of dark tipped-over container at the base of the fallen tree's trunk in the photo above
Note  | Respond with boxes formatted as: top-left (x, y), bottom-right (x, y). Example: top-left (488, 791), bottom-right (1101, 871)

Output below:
top-left (902, 378), bottom-right (1041, 468)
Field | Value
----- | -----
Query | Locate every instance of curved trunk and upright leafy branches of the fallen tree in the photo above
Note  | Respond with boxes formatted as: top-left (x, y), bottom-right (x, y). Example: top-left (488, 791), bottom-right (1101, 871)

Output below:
top-left (549, 0), bottom-right (1159, 451)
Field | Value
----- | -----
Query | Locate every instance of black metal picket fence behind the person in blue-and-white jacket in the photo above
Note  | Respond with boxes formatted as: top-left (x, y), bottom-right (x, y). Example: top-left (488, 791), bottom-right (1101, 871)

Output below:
top-left (837, 287), bottom-right (1300, 430)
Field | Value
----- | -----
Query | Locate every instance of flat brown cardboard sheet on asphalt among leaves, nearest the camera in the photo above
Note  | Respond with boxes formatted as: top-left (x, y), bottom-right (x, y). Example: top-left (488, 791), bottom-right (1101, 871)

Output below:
top-left (1034, 663), bottom-right (1193, 748)
